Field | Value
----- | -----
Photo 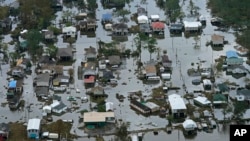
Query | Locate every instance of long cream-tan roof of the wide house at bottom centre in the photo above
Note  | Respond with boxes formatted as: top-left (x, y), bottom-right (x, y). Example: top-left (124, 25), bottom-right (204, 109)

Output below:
top-left (83, 112), bottom-right (115, 122)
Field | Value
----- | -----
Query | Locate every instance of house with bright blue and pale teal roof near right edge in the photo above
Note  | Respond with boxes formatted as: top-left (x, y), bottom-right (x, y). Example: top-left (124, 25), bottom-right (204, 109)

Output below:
top-left (225, 50), bottom-right (244, 66)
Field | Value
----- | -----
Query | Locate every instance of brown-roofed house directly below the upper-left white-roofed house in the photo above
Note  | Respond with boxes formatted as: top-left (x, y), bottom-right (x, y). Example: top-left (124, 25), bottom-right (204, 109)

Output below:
top-left (56, 48), bottom-right (73, 61)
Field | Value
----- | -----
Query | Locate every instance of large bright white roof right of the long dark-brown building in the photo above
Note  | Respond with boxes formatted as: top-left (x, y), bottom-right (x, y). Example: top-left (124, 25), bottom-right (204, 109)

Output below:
top-left (168, 94), bottom-right (187, 110)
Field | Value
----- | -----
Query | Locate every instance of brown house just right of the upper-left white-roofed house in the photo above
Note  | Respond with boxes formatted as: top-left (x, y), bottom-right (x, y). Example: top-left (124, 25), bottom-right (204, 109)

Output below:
top-left (79, 19), bottom-right (97, 31)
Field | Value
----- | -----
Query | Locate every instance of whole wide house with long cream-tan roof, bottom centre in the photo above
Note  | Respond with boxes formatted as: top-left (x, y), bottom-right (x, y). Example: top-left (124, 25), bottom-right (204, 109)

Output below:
top-left (83, 112), bottom-right (115, 127)
